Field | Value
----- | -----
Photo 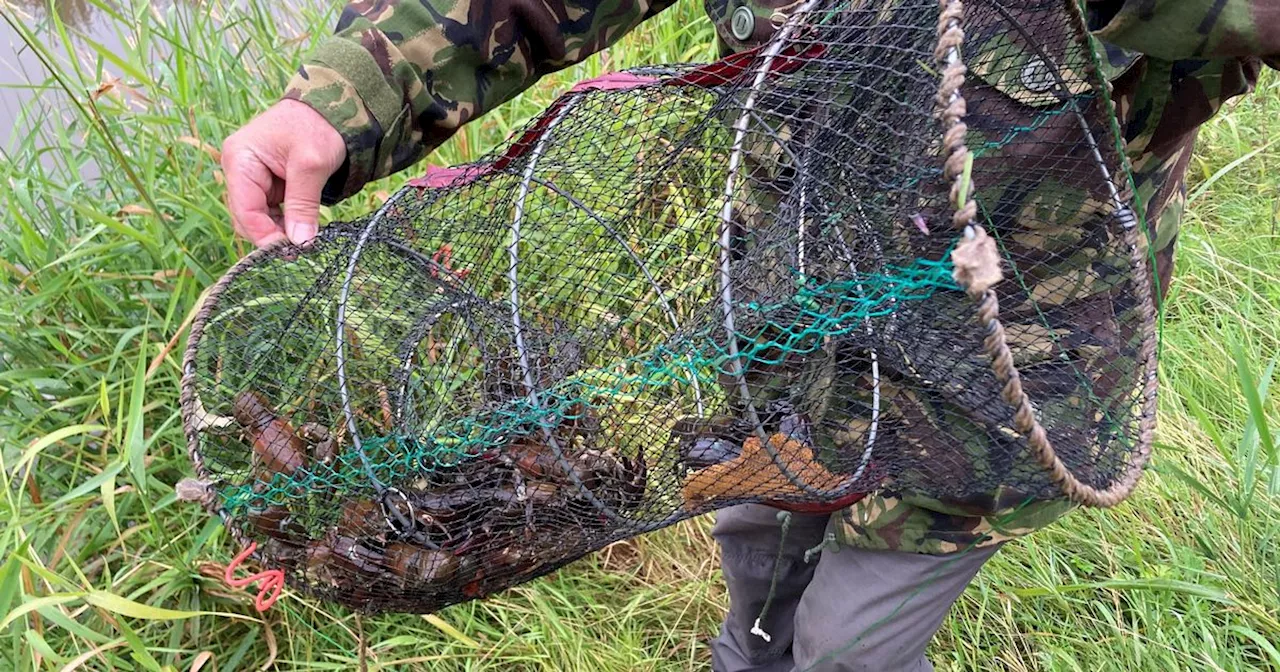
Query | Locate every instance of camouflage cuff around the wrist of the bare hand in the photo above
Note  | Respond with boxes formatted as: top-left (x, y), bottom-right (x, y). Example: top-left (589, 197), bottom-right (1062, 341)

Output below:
top-left (284, 38), bottom-right (402, 205)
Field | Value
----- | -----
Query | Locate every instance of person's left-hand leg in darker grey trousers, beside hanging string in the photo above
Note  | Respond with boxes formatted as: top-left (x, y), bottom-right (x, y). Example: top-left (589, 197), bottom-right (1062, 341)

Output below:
top-left (710, 504), bottom-right (831, 672)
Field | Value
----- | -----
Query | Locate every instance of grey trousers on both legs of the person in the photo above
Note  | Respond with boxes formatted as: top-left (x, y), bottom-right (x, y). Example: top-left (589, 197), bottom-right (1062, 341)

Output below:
top-left (712, 504), bottom-right (997, 672)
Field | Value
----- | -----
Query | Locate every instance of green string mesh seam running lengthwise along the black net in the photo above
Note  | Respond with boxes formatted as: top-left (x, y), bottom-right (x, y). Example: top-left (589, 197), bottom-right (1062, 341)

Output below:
top-left (221, 243), bottom-right (959, 515)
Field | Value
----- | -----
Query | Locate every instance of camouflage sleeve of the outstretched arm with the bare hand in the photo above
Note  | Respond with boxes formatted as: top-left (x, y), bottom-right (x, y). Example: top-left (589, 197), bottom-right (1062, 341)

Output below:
top-left (284, 0), bottom-right (673, 204)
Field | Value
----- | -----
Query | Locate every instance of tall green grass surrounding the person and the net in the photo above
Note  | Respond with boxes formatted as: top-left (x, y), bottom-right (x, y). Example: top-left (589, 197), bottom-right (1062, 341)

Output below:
top-left (0, 0), bottom-right (1280, 672)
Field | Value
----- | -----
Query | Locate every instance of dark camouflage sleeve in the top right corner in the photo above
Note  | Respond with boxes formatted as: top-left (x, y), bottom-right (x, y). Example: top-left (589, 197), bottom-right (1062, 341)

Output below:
top-left (1096, 0), bottom-right (1280, 67)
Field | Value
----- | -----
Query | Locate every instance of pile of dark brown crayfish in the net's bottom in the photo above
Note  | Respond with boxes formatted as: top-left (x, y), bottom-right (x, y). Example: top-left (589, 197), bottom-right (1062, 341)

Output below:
top-left (222, 392), bottom-right (645, 603)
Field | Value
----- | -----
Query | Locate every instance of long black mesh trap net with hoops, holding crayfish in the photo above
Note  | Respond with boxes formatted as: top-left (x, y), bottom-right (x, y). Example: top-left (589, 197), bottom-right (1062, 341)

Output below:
top-left (183, 0), bottom-right (1155, 612)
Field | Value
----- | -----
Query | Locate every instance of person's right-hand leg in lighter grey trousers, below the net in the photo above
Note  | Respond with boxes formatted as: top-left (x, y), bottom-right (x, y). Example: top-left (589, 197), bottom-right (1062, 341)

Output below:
top-left (794, 547), bottom-right (998, 672)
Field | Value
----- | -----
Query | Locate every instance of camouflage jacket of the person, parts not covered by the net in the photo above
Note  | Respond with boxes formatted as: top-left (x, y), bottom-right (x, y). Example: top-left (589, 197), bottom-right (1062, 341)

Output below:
top-left (285, 0), bottom-right (1280, 553)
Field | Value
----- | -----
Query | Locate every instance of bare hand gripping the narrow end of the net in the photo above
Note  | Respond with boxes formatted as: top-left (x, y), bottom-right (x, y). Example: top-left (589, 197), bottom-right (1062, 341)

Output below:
top-left (223, 100), bottom-right (347, 247)
